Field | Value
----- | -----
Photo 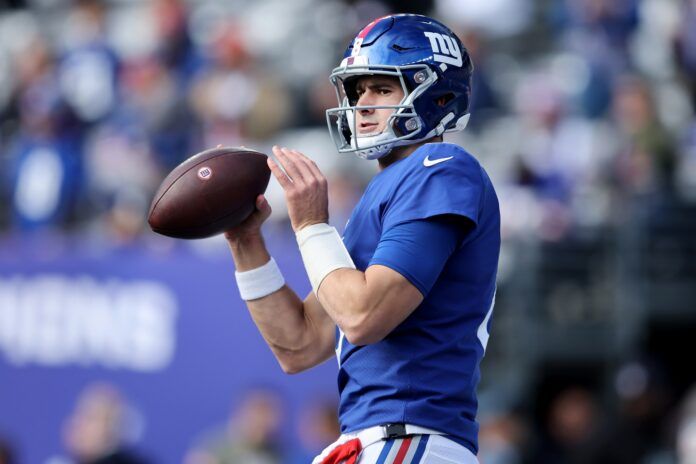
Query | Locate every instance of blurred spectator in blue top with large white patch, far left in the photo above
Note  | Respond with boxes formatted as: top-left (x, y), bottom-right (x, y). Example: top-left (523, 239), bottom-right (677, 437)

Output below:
top-left (9, 37), bottom-right (83, 234)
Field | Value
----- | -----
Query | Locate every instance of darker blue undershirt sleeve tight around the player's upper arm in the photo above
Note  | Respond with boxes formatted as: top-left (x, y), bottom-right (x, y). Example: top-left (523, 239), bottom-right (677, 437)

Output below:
top-left (369, 215), bottom-right (471, 297)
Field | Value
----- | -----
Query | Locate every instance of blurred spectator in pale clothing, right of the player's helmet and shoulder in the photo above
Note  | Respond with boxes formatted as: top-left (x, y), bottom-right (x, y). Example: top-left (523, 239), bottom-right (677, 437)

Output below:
top-left (514, 72), bottom-right (608, 240)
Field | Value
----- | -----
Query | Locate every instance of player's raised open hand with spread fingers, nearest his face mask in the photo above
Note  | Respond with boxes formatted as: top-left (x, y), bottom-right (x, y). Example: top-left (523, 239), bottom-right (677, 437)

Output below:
top-left (268, 146), bottom-right (329, 232)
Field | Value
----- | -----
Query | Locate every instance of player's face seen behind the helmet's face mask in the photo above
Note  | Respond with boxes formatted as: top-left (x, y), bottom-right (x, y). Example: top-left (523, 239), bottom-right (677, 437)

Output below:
top-left (355, 76), bottom-right (404, 137)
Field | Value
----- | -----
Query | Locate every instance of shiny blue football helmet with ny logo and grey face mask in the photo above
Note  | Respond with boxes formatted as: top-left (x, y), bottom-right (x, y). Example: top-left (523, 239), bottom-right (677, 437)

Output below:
top-left (326, 15), bottom-right (473, 159)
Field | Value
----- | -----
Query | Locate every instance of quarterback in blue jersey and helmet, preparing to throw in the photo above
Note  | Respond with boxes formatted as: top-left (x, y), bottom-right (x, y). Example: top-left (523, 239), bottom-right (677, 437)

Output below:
top-left (226, 15), bottom-right (500, 464)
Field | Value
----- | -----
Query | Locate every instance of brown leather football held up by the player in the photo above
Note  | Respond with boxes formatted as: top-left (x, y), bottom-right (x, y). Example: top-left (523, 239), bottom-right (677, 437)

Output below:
top-left (147, 147), bottom-right (271, 239)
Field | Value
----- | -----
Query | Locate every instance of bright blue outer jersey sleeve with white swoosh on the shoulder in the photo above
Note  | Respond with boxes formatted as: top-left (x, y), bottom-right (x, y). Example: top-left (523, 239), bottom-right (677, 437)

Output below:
top-left (382, 149), bottom-right (485, 231)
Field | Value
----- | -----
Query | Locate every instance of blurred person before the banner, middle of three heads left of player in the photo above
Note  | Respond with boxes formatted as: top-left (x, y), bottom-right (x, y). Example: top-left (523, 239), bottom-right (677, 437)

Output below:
top-left (184, 389), bottom-right (284, 464)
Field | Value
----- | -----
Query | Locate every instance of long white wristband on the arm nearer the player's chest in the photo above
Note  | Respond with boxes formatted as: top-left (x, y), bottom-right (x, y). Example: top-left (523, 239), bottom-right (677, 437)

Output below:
top-left (295, 223), bottom-right (355, 294)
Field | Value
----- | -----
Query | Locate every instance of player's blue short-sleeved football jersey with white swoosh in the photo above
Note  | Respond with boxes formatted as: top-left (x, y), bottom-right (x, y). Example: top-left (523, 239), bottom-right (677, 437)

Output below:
top-left (336, 143), bottom-right (500, 453)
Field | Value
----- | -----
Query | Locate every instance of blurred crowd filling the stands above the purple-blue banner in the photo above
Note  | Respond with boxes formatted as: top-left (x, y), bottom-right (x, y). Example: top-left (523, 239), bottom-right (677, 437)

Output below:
top-left (0, 0), bottom-right (696, 243)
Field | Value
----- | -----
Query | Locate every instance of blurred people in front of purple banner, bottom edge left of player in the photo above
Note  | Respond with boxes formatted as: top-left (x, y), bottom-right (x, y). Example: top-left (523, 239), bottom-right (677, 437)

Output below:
top-left (0, 381), bottom-right (340, 464)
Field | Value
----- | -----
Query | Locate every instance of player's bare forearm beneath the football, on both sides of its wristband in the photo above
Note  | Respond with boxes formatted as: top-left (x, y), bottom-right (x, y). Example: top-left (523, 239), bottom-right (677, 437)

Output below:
top-left (228, 234), bottom-right (326, 372)
